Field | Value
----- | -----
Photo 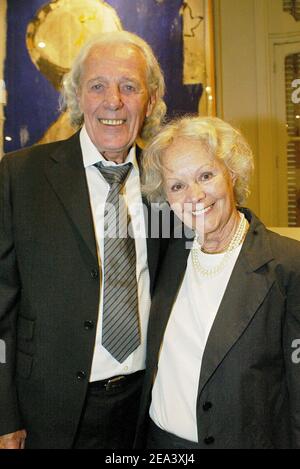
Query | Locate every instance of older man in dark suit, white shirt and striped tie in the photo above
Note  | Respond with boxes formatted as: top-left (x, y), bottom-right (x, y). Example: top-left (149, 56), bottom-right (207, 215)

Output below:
top-left (0, 31), bottom-right (165, 449)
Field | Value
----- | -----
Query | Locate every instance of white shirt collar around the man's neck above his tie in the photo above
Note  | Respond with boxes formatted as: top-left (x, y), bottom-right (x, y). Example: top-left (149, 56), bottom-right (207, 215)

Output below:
top-left (79, 125), bottom-right (139, 171)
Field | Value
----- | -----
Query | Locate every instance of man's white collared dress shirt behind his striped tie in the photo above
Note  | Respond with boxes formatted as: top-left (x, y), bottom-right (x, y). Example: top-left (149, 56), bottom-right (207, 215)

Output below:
top-left (80, 126), bottom-right (150, 381)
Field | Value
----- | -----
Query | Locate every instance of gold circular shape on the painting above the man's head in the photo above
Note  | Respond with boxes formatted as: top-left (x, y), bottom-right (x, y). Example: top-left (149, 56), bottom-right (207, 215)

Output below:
top-left (26, 0), bottom-right (122, 90)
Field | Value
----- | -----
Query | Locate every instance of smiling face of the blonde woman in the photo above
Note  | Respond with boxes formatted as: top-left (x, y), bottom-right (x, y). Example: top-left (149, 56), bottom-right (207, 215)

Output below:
top-left (163, 138), bottom-right (237, 240)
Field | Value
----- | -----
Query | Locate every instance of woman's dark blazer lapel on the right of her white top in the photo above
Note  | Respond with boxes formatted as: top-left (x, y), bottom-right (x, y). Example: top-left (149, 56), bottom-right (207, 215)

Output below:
top-left (198, 216), bottom-right (274, 395)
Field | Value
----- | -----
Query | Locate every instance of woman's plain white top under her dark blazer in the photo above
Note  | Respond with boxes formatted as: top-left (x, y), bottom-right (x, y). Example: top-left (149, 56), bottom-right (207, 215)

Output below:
top-left (150, 241), bottom-right (242, 442)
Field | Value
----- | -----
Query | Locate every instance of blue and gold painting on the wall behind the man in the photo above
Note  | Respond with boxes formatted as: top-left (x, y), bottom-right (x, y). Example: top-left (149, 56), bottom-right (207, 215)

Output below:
top-left (4, 0), bottom-right (215, 152)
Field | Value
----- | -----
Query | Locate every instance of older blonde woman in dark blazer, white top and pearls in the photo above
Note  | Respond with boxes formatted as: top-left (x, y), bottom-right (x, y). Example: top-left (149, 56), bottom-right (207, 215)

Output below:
top-left (137, 117), bottom-right (300, 449)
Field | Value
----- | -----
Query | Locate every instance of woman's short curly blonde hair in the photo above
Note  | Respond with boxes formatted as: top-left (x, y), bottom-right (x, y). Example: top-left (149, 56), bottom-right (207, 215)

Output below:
top-left (142, 116), bottom-right (254, 205)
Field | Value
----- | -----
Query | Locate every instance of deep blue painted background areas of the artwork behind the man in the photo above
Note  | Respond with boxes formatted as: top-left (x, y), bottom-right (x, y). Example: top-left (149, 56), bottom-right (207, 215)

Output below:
top-left (4, 0), bottom-right (202, 152)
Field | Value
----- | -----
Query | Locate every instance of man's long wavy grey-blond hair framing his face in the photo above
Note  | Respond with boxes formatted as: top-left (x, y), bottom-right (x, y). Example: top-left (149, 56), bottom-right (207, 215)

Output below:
top-left (60, 31), bottom-right (166, 141)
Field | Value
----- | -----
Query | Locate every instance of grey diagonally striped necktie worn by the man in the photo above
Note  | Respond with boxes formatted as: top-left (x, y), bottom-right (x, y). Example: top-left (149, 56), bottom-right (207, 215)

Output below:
top-left (95, 163), bottom-right (140, 363)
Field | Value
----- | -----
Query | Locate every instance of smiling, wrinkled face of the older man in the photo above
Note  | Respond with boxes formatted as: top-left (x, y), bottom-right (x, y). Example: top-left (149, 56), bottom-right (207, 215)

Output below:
top-left (78, 44), bottom-right (155, 163)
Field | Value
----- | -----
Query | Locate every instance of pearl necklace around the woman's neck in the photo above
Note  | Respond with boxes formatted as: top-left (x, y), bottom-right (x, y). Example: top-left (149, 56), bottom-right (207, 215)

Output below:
top-left (192, 213), bottom-right (249, 277)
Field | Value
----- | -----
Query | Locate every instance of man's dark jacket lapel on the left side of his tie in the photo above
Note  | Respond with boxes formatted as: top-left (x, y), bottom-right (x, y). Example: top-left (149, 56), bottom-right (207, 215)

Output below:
top-left (45, 133), bottom-right (97, 258)
